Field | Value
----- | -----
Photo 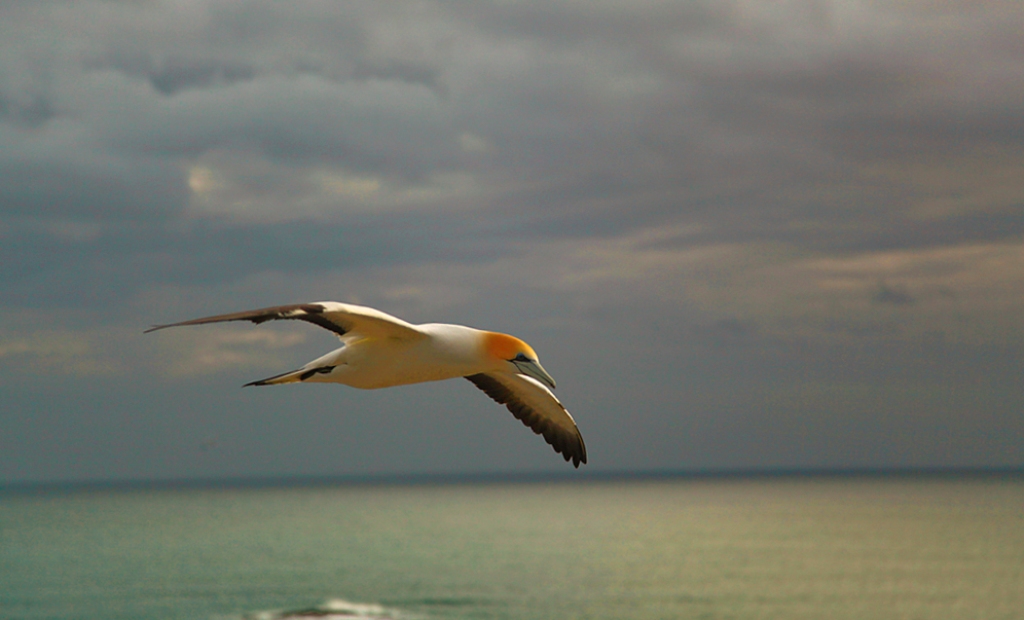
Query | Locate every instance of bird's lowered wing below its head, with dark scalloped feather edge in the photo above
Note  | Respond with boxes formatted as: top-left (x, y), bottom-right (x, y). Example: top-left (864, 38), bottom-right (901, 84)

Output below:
top-left (466, 372), bottom-right (587, 467)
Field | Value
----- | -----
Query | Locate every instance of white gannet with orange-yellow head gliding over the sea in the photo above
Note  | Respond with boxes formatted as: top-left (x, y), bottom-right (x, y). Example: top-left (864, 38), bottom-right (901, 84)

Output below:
top-left (143, 301), bottom-right (587, 468)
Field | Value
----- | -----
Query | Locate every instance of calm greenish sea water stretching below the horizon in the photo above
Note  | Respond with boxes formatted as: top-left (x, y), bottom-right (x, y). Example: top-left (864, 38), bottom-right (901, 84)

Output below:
top-left (0, 476), bottom-right (1024, 620)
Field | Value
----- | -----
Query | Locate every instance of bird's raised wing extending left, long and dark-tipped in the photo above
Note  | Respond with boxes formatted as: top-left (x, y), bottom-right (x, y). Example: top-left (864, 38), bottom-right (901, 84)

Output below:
top-left (145, 301), bottom-right (424, 338)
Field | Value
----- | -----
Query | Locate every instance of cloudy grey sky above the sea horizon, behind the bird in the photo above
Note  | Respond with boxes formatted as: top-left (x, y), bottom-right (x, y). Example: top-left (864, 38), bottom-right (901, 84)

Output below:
top-left (0, 0), bottom-right (1024, 484)
